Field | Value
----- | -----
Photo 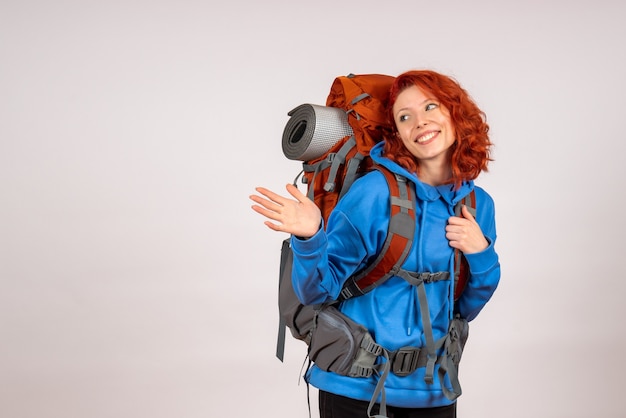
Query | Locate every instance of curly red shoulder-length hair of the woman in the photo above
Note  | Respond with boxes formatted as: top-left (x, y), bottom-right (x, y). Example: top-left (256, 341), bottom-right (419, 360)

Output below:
top-left (383, 70), bottom-right (492, 187)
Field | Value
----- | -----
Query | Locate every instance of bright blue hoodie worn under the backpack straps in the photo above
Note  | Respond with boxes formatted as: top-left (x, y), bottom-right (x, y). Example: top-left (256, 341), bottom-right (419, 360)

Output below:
top-left (291, 143), bottom-right (500, 408)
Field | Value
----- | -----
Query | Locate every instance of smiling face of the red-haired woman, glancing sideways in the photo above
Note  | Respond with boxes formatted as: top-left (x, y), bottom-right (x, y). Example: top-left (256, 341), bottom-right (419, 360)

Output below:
top-left (393, 86), bottom-right (455, 165)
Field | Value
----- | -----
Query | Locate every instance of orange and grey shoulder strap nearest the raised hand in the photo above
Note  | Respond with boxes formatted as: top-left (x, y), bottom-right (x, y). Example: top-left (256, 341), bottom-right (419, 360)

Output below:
top-left (339, 166), bottom-right (415, 300)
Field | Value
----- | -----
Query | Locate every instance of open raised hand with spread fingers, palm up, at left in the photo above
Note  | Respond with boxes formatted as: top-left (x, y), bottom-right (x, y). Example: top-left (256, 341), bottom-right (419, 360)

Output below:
top-left (250, 184), bottom-right (322, 238)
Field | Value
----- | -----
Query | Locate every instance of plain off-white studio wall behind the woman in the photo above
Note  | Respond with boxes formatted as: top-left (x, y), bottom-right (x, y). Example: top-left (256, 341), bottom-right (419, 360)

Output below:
top-left (0, 0), bottom-right (626, 418)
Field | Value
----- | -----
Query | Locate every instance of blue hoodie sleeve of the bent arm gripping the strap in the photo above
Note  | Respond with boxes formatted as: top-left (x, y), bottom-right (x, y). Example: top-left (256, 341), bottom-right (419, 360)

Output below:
top-left (450, 187), bottom-right (500, 321)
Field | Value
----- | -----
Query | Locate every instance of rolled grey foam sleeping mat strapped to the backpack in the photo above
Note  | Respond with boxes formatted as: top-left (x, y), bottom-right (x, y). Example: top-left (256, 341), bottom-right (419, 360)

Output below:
top-left (282, 104), bottom-right (353, 161)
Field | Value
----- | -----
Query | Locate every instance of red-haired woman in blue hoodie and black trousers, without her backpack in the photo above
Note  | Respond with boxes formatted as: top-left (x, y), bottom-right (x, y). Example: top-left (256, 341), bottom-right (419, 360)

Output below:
top-left (251, 71), bottom-right (500, 418)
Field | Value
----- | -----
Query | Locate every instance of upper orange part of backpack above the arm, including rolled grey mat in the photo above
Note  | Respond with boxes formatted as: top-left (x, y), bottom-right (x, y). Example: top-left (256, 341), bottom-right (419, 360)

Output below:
top-left (283, 74), bottom-right (394, 227)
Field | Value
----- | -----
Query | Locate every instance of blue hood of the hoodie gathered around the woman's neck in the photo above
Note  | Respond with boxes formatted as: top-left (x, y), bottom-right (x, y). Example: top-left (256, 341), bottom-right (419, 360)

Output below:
top-left (370, 141), bottom-right (474, 206)
